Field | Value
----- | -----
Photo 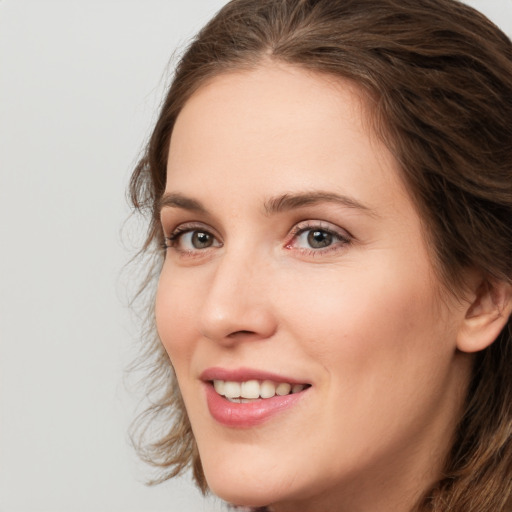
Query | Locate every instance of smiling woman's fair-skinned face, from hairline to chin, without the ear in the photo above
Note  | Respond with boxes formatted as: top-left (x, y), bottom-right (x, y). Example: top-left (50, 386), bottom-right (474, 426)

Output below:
top-left (156, 64), bottom-right (469, 512)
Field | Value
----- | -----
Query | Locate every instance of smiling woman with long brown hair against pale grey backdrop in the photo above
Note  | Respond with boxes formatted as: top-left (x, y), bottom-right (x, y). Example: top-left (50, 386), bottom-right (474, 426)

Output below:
top-left (131, 0), bottom-right (512, 512)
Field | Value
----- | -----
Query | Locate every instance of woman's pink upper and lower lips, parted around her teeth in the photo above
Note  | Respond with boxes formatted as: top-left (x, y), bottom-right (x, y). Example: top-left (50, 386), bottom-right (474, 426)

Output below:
top-left (201, 368), bottom-right (309, 428)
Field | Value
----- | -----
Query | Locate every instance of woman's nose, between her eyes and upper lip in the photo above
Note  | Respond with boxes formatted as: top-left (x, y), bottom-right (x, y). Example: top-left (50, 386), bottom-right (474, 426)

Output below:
top-left (199, 248), bottom-right (277, 346)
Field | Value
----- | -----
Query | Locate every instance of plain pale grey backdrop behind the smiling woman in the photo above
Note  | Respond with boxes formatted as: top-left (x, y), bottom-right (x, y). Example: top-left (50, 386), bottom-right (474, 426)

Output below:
top-left (0, 0), bottom-right (512, 512)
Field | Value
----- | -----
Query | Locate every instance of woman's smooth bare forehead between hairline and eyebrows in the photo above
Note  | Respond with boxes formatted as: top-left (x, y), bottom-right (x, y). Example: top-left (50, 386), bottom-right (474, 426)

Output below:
top-left (167, 64), bottom-right (408, 217)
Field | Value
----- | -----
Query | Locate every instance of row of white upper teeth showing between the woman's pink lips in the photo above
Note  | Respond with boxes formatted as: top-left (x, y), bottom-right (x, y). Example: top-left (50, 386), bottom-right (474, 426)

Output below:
top-left (213, 379), bottom-right (309, 403)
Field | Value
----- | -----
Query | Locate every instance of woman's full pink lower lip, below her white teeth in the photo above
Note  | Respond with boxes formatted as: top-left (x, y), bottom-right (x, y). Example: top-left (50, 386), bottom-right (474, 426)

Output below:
top-left (206, 383), bottom-right (309, 428)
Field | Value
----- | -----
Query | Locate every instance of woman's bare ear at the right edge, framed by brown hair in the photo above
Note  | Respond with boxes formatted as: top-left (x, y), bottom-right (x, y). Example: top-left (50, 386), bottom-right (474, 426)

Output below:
top-left (457, 280), bottom-right (512, 352)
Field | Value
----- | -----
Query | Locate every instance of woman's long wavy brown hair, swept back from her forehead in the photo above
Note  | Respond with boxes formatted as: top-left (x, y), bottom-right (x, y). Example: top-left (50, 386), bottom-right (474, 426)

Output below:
top-left (130, 0), bottom-right (512, 512)
